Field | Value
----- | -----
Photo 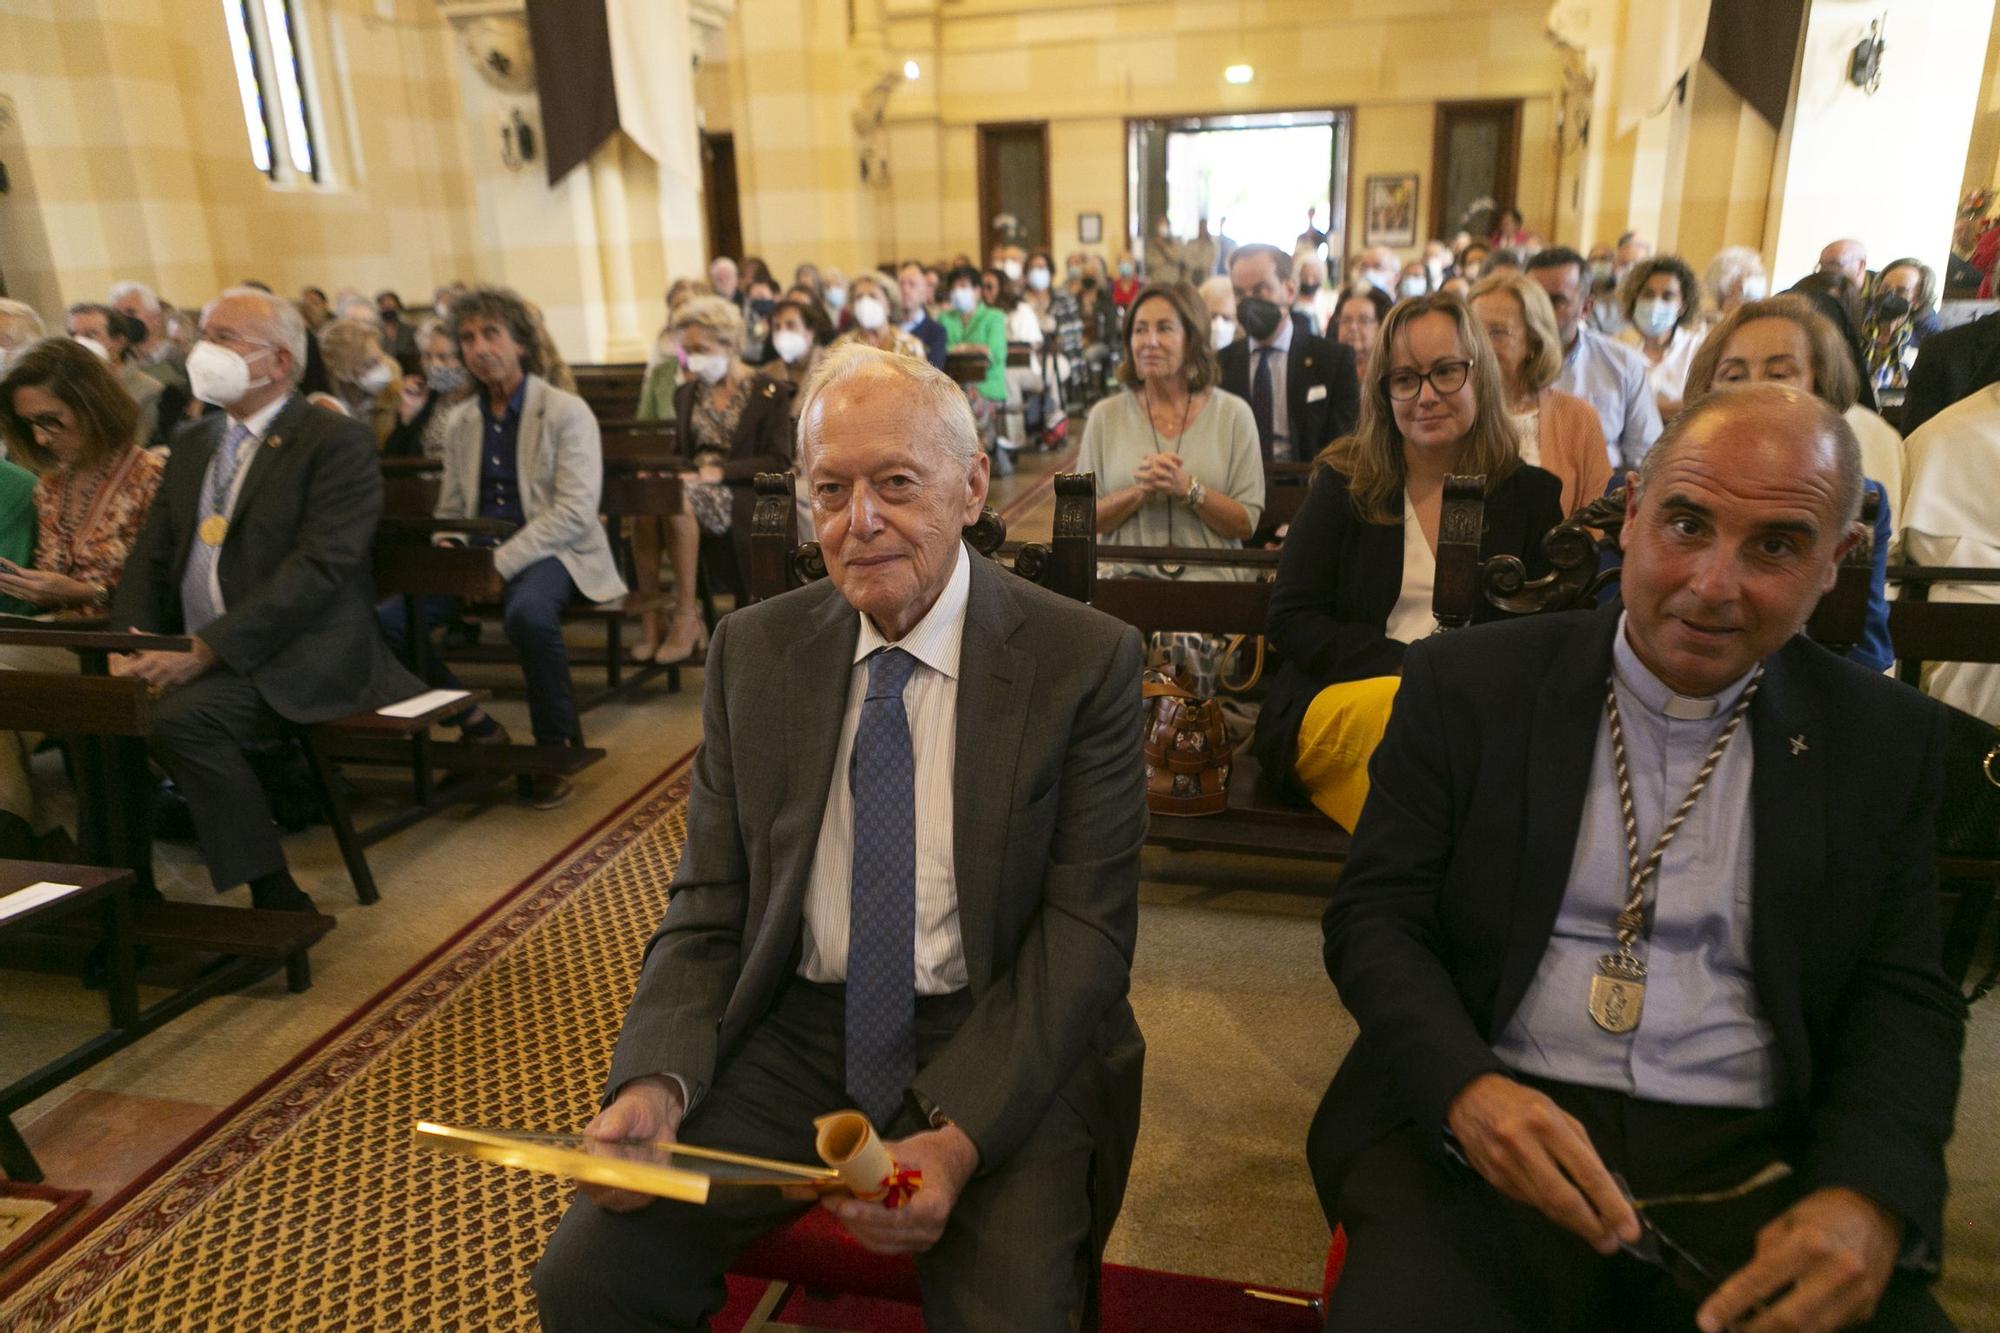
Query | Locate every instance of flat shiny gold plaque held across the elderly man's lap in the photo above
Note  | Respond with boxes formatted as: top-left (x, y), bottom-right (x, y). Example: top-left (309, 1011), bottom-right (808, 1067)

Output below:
top-left (416, 1121), bottom-right (846, 1203)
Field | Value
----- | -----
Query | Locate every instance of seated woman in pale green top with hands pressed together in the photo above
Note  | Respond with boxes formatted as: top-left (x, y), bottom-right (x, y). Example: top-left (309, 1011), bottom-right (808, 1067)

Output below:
top-left (1074, 284), bottom-right (1264, 578)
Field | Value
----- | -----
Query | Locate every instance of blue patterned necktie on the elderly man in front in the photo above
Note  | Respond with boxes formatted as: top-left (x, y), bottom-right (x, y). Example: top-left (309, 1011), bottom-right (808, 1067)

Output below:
top-left (846, 648), bottom-right (916, 1133)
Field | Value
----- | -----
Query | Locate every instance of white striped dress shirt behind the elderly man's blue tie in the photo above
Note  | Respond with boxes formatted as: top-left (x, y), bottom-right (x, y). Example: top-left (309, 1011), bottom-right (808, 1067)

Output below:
top-left (798, 542), bottom-right (972, 995)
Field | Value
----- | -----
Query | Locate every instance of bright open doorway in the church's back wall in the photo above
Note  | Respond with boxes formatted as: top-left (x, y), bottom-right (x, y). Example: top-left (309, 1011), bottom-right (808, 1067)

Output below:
top-left (1126, 110), bottom-right (1354, 278)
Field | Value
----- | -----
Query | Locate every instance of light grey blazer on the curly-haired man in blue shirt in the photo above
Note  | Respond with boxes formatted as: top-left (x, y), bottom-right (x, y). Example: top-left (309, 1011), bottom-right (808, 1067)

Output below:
top-left (434, 374), bottom-right (626, 602)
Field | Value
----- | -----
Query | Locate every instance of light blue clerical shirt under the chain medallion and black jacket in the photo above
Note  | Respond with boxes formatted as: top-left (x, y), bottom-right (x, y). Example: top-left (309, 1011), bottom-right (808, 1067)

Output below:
top-left (1494, 620), bottom-right (1778, 1107)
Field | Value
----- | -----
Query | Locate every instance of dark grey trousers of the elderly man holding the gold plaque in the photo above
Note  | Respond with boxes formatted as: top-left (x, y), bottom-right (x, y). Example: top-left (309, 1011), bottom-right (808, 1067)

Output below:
top-left (534, 981), bottom-right (1090, 1333)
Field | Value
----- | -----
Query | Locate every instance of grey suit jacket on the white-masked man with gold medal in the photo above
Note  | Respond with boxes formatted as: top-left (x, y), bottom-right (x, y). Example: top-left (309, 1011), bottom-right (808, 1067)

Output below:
top-left (112, 394), bottom-right (424, 723)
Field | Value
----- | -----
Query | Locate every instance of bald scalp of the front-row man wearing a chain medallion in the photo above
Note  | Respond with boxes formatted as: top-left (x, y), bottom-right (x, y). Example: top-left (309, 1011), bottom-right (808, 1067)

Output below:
top-left (1638, 380), bottom-right (1862, 530)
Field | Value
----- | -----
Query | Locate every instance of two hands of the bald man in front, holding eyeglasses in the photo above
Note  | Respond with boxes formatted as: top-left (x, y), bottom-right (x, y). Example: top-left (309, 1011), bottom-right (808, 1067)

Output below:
top-left (1446, 1073), bottom-right (1902, 1333)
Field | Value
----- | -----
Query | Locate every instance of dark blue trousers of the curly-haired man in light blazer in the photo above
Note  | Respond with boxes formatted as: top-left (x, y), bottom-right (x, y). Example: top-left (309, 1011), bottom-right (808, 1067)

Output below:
top-left (376, 556), bottom-right (582, 745)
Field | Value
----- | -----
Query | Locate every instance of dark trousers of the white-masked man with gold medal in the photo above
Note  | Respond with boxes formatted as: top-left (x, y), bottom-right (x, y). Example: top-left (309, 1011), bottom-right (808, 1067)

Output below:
top-left (141, 664), bottom-right (284, 893)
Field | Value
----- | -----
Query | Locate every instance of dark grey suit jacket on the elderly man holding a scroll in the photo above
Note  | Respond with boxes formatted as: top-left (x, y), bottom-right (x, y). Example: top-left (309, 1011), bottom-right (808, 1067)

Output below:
top-left (610, 540), bottom-right (1146, 1243)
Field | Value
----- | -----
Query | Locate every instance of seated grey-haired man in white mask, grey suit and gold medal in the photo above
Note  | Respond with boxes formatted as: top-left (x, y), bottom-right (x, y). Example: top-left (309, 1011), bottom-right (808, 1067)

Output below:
top-left (112, 288), bottom-right (422, 911)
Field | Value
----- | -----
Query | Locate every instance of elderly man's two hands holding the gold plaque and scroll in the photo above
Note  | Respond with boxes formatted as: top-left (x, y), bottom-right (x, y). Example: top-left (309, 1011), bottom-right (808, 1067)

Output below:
top-left (578, 1077), bottom-right (980, 1255)
